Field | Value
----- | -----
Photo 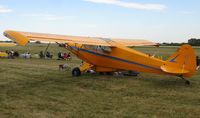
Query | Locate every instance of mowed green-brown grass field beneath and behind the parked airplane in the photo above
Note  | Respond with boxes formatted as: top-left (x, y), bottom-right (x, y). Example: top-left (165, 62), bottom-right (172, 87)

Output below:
top-left (0, 45), bottom-right (200, 118)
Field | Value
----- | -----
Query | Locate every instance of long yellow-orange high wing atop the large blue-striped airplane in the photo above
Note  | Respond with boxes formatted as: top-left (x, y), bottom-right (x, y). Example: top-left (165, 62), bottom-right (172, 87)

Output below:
top-left (4, 30), bottom-right (156, 46)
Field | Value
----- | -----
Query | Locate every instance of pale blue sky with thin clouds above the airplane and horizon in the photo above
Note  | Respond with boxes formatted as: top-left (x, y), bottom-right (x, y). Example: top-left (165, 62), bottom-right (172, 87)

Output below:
top-left (0, 0), bottom-right (200, 42)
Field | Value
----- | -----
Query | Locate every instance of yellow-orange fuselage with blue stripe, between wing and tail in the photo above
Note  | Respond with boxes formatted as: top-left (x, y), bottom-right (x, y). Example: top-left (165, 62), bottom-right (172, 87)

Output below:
top-left (68, 44), bottom-right (164, 74)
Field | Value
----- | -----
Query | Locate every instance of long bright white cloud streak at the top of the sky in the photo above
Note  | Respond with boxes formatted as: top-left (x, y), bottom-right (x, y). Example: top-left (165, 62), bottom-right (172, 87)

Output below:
top-left (83, 0), bottom-right (167, 11)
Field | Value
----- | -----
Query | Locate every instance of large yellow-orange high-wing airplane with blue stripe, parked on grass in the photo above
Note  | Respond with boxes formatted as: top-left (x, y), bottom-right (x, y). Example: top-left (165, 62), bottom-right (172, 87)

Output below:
top-left (4, 30), bottom-right (197, 84)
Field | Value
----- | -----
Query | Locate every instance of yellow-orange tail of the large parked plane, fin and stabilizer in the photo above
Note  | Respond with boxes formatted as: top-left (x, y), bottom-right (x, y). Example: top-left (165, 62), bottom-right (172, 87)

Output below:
top-left (161, 44), bottom-right (197, 77)
